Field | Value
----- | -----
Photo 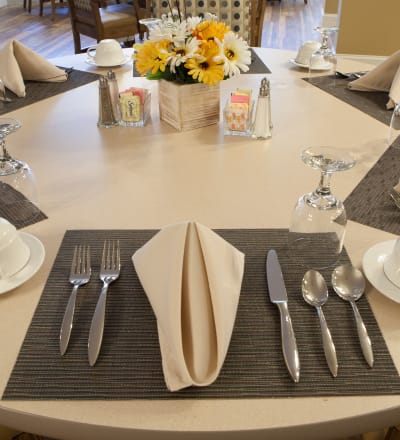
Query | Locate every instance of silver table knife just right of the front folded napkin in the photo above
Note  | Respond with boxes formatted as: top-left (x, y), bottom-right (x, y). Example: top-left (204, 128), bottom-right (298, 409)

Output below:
top-left (266, 249), bottom-right (300, 382)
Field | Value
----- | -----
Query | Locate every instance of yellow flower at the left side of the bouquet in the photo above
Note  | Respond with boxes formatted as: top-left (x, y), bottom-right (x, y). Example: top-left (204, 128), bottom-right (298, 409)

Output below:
top-left (134, 41), bottom-right (168, 76)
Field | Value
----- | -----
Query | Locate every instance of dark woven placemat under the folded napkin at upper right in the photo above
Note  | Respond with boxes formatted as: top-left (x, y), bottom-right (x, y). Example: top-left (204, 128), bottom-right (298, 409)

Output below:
top-left (303, 75), bottom-right (392, 125)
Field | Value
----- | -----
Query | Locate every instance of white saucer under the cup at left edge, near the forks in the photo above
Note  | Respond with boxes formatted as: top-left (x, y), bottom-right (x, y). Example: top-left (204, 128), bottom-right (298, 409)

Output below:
top-left (0, 232), bottom-right (45, 294)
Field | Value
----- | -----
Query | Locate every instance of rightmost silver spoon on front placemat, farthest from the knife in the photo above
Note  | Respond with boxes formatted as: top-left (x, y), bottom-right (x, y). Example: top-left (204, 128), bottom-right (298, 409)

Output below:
top-left (332, 265), bottom-right (374, 367)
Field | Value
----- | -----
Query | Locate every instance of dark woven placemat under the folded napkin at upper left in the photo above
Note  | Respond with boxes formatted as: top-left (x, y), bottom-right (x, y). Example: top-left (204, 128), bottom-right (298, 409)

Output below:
top-left (0, 67), bottom-right (99, 115)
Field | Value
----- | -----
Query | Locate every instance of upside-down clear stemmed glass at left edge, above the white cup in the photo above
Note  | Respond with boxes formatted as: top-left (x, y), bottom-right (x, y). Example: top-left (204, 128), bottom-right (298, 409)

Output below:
top-left (0, 118), bottom-right (40, 227)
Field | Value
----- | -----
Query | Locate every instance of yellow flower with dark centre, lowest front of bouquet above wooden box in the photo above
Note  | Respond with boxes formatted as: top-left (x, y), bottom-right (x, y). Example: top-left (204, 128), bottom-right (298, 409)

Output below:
top-left (185, 41), bottom-right (224, 86)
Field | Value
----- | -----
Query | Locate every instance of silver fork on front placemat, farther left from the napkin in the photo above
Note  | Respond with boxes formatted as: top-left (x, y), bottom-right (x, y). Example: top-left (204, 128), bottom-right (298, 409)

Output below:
top-left (60, 245), bottom-right (91, 356)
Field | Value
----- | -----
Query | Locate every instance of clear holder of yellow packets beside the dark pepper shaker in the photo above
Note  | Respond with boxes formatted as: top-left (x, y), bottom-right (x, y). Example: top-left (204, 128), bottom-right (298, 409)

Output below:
top-left (120, 91), bottom-right (151, 127)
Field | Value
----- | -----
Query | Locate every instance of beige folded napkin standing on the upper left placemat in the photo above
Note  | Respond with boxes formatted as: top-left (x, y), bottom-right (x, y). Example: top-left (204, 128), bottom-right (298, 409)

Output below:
top-left (0, 40), bottom-right (68, 97)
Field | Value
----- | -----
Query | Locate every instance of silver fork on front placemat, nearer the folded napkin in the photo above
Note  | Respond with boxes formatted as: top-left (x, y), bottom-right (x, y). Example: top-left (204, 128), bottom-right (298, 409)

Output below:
top-left (88, 240), bottom-right (121, 367)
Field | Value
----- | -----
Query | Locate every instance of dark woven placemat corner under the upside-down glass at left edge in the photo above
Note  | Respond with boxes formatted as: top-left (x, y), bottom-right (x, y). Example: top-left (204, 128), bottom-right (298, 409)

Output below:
top-left (0, 182), bottom-right (47, 229)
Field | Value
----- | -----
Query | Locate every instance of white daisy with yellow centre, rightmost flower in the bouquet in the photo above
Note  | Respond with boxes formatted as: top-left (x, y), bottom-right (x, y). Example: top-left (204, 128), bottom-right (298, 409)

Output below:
top-left (216, 31), bottom-right (251, 78)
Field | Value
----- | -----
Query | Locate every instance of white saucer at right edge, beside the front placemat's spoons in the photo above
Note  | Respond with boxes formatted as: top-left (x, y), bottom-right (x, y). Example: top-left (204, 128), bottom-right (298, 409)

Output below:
top-left (362, 240), bottom-right (400, 303)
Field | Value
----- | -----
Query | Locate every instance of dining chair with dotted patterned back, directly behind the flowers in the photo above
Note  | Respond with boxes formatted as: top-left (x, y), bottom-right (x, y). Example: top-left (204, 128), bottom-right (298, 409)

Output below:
top-left (152, 0), bottom-right (265, 46)
